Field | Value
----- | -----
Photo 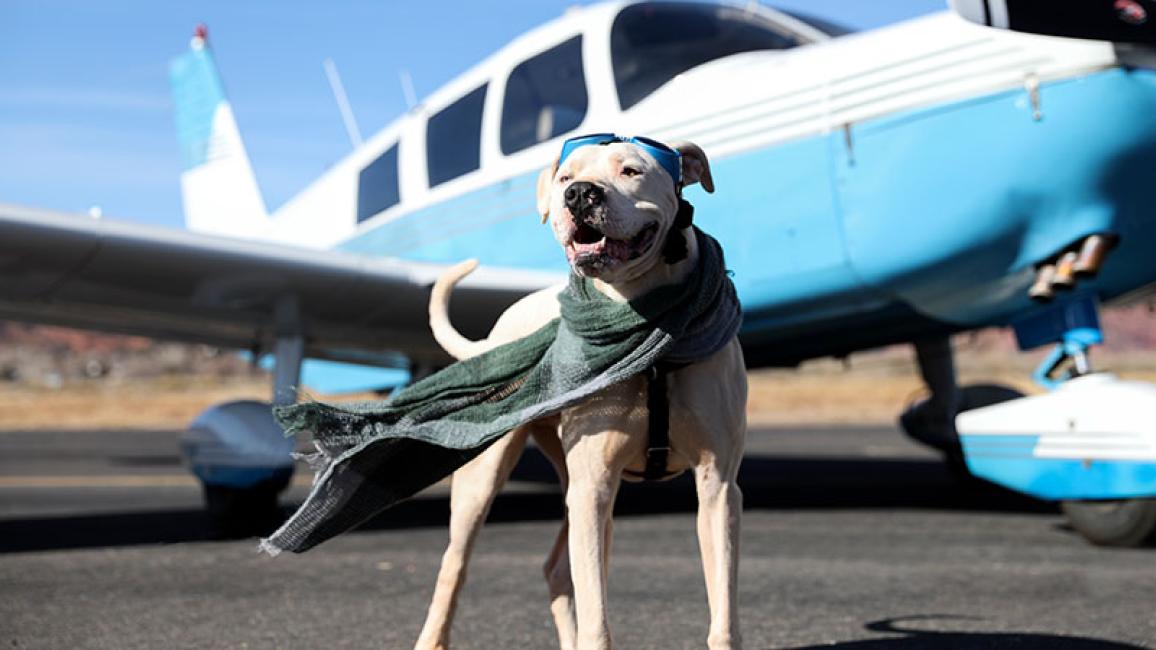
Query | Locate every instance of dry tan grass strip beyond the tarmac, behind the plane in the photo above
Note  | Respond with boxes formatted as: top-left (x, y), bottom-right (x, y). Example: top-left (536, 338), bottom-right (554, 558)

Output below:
top-left (0, 350), bottom-right (1156, 430)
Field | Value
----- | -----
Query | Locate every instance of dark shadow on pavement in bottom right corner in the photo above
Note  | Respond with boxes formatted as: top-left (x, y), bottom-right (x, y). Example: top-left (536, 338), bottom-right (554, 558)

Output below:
top-left (791, 615), bottom-right (1142, 650)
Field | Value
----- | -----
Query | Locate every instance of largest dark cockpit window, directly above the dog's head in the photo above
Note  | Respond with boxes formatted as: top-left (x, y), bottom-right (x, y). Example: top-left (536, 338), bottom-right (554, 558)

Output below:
top-left (610, 2), bottom-right (801, 110)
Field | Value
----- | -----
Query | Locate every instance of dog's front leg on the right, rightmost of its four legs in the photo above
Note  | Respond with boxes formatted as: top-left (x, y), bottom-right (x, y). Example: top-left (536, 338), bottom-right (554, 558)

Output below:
top-left (695, 457), bottom-right (742, 650)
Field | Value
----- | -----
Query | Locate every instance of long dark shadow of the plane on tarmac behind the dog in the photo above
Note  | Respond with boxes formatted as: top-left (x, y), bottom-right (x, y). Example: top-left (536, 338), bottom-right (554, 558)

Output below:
top-left (0, 449), bottom-right (1055, 553)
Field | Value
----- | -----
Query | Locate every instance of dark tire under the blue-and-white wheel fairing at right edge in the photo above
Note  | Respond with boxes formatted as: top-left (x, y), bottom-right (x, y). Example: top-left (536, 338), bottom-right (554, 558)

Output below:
top-left (1061, 498), bottom-right (1156, 548)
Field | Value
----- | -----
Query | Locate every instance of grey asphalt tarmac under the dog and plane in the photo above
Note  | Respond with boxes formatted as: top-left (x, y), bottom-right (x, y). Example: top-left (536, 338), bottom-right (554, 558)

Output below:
top-left (0, 427), bottom-right (1156, 650)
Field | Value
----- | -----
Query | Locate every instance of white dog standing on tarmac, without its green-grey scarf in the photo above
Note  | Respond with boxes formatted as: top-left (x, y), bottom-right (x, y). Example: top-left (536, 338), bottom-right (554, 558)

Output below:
top-left (416, 136), bottom-right (747, 649)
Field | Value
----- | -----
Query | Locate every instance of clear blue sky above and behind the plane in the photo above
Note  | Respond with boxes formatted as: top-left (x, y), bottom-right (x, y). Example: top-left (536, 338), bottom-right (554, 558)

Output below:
top-left (0, 0), bottom-right (946, 227)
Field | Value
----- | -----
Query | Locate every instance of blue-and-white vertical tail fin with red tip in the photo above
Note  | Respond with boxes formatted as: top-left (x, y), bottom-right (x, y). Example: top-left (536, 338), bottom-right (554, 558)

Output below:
top-left (169, 25), bottom-right (271, 238)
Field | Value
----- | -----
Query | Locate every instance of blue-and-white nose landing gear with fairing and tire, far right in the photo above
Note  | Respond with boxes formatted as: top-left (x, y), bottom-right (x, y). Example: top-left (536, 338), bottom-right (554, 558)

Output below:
top-left (955, 293), bottom-right (1156, 546)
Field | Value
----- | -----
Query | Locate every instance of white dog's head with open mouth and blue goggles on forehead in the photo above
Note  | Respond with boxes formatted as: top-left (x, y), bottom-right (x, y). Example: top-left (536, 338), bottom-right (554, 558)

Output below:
top-left (538, 139), bottom-right (714, 285)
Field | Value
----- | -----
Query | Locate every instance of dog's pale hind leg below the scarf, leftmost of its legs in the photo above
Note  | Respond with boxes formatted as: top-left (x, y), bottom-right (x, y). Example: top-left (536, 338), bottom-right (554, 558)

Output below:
top-left (414, 426), bottom-right (529, 650)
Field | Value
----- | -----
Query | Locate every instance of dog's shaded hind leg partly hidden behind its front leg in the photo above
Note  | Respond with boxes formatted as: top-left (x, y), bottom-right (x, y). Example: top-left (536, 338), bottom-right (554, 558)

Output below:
top-left (533, 422), bottom-right (578, 650)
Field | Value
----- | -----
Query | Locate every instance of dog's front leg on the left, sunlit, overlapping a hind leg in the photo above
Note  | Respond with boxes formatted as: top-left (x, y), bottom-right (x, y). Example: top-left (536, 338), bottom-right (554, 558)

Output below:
top-left (566, 435), bottom-right (622, 650)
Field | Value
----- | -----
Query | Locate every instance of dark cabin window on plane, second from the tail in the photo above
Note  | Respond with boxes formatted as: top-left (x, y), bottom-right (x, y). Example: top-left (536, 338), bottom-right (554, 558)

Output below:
top-left (425, 84), bottom-right (488, 187)
